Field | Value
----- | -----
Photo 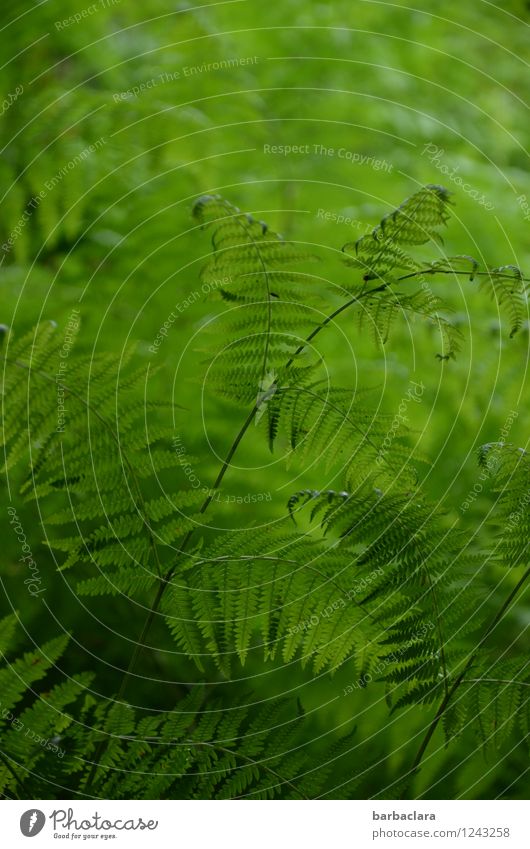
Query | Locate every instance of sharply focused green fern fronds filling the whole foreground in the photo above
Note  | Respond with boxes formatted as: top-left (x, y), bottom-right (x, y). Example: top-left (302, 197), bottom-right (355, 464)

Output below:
top-left (0, 185), bottom-right (530, 798)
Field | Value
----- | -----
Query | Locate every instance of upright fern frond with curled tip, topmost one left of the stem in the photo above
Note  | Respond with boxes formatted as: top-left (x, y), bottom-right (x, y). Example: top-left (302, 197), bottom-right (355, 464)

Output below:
top-left (193, 195), bottom-right (315, 402)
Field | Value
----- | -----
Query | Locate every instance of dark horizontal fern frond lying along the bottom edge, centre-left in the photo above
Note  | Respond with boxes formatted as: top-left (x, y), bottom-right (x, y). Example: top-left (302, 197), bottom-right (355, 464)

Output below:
top-left (55, 687), bottom-right (352, 799)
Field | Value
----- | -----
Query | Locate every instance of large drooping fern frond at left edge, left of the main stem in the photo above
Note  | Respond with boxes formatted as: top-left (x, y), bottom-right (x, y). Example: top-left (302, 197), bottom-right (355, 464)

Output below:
top-left (3, 325), bottom-right (204, 594)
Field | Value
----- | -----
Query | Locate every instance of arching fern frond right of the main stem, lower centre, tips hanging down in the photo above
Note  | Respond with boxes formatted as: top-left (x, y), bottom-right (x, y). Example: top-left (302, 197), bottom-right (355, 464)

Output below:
top-left (162, 520), bottom-right (382, 674)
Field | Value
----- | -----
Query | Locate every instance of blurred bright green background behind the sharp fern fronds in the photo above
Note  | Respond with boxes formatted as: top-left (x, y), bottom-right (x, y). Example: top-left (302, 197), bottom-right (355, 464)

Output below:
top-left (0, 0), bottom-right (530, 798)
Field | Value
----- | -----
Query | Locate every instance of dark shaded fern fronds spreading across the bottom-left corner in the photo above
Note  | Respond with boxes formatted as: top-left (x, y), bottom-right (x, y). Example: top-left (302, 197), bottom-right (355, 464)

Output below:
top-left (0, 617), bottom-right (351, 799)
